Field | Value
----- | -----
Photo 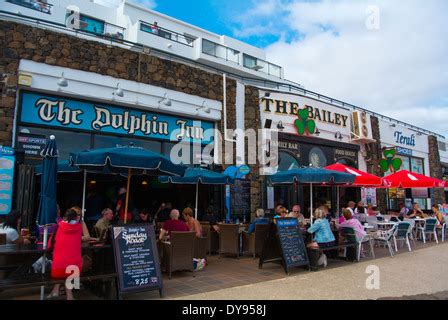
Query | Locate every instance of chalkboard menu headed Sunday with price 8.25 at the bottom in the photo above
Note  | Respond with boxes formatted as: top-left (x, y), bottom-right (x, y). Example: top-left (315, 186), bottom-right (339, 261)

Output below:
top-left (113, 224), bottom-right (163, 297)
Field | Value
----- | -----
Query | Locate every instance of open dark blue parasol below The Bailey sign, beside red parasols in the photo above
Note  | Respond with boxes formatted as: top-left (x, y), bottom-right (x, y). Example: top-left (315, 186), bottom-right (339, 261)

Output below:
top-left (268, 167), bottom-right (356, 184)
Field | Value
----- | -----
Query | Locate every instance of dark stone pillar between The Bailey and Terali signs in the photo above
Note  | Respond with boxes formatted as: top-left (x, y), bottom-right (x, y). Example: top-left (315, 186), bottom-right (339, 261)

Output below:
top-left (366, 116), bottom-right (387, 212)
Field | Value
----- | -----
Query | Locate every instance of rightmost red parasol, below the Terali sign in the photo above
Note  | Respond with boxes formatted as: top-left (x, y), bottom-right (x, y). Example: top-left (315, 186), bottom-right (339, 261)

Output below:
top-left (383, 170), bottom-right (444, 188)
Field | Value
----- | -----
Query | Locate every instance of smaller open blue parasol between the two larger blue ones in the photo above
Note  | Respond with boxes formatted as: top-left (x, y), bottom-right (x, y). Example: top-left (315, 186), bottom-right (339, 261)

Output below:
top-left (159, 168), bottom-right (235, 184)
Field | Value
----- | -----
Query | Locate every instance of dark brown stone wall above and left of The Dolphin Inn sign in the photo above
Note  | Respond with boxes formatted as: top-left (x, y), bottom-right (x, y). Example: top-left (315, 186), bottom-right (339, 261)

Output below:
top-left (0, 21), bottom-right (236, 146)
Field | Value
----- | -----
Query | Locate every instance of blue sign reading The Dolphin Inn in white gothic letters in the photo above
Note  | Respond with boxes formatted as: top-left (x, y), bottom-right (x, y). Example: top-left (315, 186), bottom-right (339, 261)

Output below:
top-left (20, 91), bottom-right (214, 144)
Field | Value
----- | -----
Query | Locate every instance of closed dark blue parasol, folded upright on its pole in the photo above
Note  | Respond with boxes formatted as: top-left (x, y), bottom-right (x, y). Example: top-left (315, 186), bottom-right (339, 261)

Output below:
top-left (37, 136), bottom-right (58, 225)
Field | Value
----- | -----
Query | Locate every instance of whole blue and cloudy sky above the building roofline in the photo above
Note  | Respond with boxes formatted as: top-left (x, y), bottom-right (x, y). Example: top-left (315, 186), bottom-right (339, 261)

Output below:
top-left (130, 0), bottom-right (448, 138)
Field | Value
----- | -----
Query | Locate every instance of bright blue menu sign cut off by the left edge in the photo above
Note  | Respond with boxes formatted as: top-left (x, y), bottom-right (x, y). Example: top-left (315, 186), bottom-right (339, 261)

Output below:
top-left (0, 146), bottom-right (15, 215)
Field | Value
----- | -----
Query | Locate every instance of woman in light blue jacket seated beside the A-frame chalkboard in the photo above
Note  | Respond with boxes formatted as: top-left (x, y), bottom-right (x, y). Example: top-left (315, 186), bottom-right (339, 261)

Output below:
top-left (308, 208), bottom-right (336, 267)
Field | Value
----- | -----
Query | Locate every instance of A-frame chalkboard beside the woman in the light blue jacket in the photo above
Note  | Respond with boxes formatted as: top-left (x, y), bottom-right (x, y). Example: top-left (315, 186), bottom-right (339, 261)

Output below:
top-left (259, 218), bottom-right (309, 274)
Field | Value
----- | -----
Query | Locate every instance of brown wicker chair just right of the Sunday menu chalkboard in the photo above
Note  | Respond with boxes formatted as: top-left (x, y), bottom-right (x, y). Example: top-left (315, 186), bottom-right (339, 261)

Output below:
top-left (162, 231), bottom-right (196, 279)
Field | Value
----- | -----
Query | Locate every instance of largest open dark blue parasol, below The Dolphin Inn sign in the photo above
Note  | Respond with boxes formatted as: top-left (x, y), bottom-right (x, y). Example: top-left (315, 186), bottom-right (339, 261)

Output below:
top-left (69, 146), bottom-right (187, 176)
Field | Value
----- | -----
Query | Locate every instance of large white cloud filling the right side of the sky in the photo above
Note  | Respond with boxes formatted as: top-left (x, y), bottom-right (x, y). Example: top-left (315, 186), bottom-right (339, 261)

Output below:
top-left (234, 0), bottom-right (448, 136)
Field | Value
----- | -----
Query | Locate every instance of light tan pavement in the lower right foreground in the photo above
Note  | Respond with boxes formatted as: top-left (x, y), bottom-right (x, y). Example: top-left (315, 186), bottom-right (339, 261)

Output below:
top-left (175, 243), bottom-right (448, 300)
